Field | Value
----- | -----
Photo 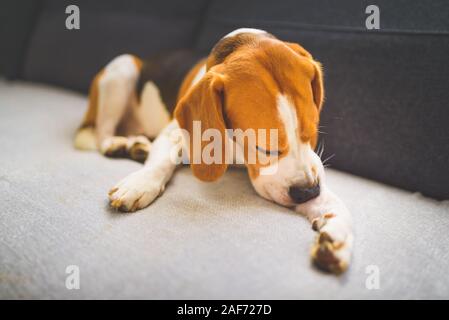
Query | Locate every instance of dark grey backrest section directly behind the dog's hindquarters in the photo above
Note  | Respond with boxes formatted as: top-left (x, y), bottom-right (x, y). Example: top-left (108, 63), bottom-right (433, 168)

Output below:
top-left (20, 0), bottom-right (206, 92)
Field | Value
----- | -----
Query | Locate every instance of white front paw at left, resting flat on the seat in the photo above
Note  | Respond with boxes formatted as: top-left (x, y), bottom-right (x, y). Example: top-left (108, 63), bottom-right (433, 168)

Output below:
top-left (108, 170), bottom-right (165, 212)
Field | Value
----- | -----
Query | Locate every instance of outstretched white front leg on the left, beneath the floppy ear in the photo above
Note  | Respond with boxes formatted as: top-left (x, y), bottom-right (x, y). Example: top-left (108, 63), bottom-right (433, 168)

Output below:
top-left (109, 120), bottom-right (182, 211)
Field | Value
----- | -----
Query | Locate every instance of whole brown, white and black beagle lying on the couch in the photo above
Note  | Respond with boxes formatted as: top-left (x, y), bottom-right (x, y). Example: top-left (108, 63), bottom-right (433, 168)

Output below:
top-left (75, 28), bottom-right (353, 274)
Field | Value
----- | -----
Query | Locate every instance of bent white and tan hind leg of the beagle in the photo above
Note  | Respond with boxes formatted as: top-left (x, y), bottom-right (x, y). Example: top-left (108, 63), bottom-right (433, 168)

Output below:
top-left (74, 54), bottom-right (147, 162)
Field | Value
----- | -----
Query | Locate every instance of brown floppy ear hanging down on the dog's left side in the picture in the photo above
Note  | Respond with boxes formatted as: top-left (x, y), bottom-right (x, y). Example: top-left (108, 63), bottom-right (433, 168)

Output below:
top-left (174, 70), bottom-right (227, 181)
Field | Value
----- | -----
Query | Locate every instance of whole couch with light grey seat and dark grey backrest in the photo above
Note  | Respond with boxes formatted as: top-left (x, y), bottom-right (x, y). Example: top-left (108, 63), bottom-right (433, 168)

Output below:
top-left (0, 0), bottom-right (449, 299)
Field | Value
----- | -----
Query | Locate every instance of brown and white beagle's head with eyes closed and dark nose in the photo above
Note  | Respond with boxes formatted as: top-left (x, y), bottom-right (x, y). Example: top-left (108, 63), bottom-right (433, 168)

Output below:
top-left (175, 29), bottom-right (324, 206)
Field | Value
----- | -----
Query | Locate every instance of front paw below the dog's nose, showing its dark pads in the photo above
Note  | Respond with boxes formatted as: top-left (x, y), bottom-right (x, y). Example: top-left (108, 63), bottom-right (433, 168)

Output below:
top-left (311, 214), bottom-right (353, 274)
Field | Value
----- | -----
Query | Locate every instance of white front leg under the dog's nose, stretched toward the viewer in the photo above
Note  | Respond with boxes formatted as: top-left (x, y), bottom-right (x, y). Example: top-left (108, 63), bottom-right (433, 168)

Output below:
top-left (296, 183), bottom-right (353, 274)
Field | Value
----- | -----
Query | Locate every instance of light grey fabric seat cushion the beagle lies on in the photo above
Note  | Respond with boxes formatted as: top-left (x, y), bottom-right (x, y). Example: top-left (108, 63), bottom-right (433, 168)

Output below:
top-left (0, 82), bottom-right (449, 299)
